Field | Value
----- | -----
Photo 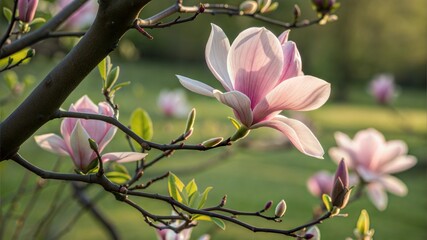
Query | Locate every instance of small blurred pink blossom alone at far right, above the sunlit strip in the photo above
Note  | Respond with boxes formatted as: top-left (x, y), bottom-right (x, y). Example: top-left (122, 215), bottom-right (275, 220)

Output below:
top-left (369, 74), bottom-right (396, 104)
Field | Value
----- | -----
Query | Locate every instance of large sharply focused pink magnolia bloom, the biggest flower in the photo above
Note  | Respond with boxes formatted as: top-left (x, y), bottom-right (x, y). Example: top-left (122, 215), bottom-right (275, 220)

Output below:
top-left (177, 24), bottom-right (330, 158)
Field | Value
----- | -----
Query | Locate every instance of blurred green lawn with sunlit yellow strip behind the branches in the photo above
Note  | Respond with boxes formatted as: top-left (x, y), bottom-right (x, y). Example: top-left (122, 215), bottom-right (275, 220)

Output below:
top-left (0, 57), bottom-right (427, 240)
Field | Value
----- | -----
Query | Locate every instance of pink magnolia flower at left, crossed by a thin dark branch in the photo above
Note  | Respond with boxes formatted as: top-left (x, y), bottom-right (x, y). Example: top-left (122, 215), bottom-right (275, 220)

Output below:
top-left (35, 95), bottom-right (147, 172)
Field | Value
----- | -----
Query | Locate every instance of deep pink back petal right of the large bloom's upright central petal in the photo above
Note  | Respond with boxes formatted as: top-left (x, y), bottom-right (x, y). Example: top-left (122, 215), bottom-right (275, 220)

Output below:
top-left (280, 41), bottom-right (303, 81)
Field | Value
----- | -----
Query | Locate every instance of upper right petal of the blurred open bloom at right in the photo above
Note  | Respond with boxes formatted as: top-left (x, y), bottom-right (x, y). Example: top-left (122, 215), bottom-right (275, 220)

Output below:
top-left (370, 140), bottom-right (408, 169)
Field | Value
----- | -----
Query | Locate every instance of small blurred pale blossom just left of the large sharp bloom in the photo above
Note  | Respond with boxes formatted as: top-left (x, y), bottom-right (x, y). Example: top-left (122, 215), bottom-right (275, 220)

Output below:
top-left (157, 89), bottom-right (190, 118)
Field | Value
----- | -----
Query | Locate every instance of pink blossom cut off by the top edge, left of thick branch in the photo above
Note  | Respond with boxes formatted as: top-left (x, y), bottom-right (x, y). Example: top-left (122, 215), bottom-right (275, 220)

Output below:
top-left (57, 0), bottom-right (98, 29)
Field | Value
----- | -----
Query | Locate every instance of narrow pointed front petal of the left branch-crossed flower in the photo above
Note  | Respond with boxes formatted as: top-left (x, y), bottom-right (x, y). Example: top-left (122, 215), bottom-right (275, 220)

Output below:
top-left (70, 120), bottom-right (95, 170)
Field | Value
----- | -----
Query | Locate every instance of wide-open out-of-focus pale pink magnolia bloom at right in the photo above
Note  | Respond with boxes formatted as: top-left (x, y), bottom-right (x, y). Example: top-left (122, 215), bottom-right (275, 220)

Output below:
top-left (329, 129), bottom-right (417, 210)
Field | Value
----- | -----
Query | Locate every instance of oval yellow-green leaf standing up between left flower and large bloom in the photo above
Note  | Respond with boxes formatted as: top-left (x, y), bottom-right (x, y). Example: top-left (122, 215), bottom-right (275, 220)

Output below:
top-left (130, 108), bottom-right (153, 141)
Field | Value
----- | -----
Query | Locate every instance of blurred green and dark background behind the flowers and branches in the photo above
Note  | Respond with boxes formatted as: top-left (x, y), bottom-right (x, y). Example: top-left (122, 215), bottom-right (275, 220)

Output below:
top-left (0, 0), bottom-right (427, 240)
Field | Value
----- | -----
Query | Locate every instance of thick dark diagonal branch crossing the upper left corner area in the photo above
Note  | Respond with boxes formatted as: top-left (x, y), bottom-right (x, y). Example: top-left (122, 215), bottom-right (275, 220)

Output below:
top-left (0, 0), bottom-right (150, 161)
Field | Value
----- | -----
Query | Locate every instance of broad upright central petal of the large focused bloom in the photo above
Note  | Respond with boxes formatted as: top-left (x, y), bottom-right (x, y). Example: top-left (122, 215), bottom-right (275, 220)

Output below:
top-left (227, 28), bottom-right (283, 109)
